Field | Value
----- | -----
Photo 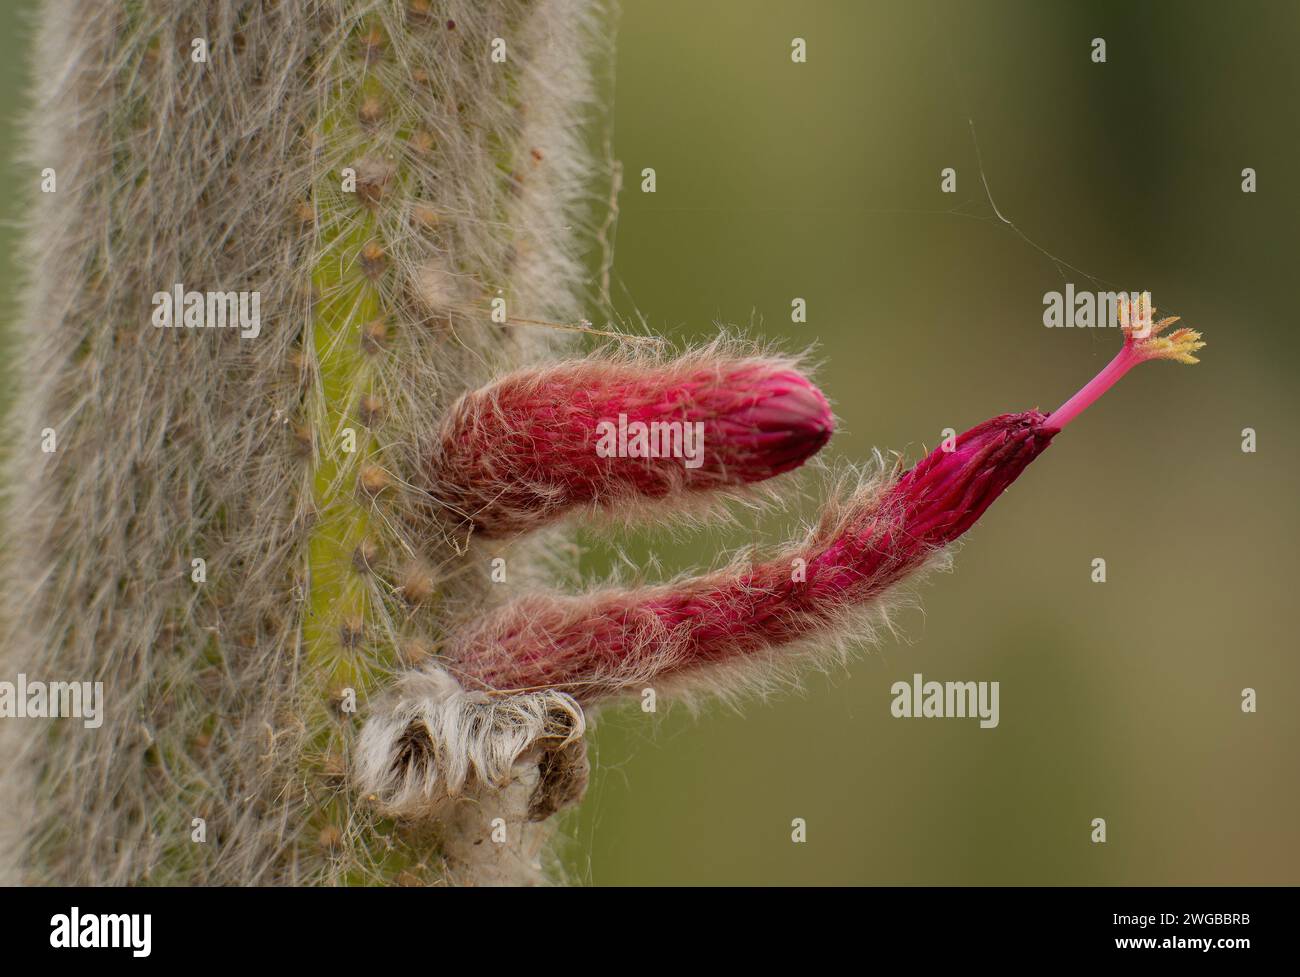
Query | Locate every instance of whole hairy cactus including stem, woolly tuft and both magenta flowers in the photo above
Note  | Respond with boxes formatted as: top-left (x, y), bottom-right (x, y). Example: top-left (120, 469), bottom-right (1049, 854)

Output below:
top-left (0, 0), bottom-right (1201, 885)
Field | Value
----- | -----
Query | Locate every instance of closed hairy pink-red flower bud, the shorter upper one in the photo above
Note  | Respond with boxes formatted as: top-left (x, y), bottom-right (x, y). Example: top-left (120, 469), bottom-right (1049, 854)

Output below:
top-left (425, 351), bottom-right (835, 537)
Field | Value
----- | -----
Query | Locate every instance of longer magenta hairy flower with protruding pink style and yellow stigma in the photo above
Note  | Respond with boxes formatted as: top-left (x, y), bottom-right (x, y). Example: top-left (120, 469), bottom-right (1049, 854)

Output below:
top-left (449, 309), bottom-right (1204, 702)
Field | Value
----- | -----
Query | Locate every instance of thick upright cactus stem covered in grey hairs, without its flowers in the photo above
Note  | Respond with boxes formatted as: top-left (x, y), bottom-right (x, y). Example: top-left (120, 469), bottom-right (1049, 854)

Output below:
top-left (3, 0), bottom-right (607, 883)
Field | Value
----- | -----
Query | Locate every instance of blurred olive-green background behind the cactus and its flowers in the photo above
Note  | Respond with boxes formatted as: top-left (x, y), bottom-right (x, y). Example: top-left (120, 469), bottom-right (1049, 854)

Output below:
top-left (0, 0), bottom-right (1300, 883)
